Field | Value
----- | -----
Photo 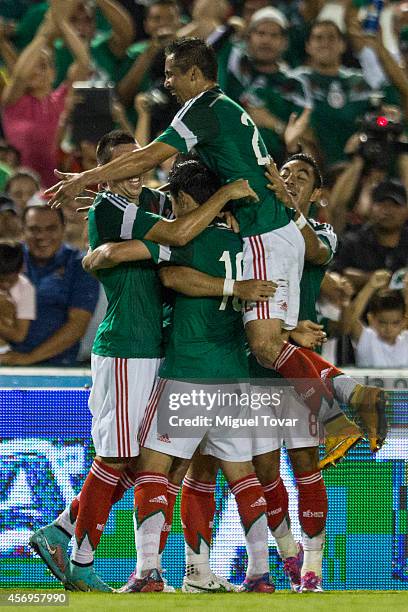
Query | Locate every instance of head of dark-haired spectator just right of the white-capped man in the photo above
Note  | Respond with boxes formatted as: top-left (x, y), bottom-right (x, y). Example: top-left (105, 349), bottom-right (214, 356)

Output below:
top-left (306, 20), bottom-right (346, 68)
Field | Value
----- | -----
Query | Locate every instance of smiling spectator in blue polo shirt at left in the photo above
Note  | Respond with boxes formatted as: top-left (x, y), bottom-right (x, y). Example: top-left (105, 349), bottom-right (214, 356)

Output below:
top-left (1, 206), bottom-right (99, 366)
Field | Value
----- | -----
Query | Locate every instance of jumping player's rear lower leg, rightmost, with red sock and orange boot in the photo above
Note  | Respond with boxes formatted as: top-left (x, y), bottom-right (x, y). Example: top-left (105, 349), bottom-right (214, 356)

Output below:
top-left (301, 349), bottom-right (387, 452)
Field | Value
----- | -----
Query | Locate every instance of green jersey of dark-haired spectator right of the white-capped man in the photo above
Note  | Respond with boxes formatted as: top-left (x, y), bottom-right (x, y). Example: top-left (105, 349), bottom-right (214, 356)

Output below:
top-left (295, 67), bottom-right (373, 165)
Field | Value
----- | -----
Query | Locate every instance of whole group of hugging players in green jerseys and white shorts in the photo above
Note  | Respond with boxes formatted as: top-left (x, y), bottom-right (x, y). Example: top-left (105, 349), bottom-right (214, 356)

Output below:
top-left (30, 38), bottom-right (385, 593)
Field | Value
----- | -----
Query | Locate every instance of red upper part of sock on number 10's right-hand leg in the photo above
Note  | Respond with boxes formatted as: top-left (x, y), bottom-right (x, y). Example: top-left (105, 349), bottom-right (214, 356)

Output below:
top-left (229, 473), bottom-right (266, 533)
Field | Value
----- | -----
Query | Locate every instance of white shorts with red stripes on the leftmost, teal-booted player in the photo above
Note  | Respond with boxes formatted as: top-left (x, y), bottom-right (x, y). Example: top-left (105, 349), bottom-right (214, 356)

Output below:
top-left (88, 354), bottom-right (161, 457)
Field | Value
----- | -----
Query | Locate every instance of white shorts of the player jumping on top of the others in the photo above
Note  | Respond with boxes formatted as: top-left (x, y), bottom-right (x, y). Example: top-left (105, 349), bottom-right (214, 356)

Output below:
top-left (243, 221), bottom-right (305, 330)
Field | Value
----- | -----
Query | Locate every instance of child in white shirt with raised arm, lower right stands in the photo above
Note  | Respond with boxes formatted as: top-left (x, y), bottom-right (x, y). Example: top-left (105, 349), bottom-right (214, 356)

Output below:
top-left (343, 270), bottom-right (408, 368)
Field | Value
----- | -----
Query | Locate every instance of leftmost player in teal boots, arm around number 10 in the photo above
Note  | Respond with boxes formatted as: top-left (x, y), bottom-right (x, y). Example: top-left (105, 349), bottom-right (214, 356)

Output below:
top-left (30, 131), bottom-right (254, 591)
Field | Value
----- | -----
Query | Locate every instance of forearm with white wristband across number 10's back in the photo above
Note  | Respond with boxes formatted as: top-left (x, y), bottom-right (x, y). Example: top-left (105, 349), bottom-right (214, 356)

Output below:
top-left (159, 266), bottom-right (277, 302)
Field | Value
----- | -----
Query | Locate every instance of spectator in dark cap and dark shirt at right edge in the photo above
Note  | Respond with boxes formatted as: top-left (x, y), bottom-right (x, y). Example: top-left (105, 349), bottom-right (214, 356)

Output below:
top-left (333, 180), bottom-right (408, 289)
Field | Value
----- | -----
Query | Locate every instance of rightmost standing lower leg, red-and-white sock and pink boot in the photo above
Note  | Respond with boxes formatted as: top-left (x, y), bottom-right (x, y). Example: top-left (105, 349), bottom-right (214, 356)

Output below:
top-left (288, 446), bottom-right (327, 592)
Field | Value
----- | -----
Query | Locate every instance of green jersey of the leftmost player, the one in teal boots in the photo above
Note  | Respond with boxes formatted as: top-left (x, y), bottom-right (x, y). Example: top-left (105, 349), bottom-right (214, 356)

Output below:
top-left (88, 188), bottom-right (165, 358)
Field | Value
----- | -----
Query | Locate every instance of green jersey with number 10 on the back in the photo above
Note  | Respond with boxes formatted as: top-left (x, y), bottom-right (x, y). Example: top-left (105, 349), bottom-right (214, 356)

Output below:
top-left (155, 223), bottom-right (248, 380)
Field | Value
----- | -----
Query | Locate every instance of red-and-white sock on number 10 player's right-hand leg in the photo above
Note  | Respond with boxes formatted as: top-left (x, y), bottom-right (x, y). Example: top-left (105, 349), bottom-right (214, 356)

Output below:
top-left (229, 474), bottom-right (269, 578)
